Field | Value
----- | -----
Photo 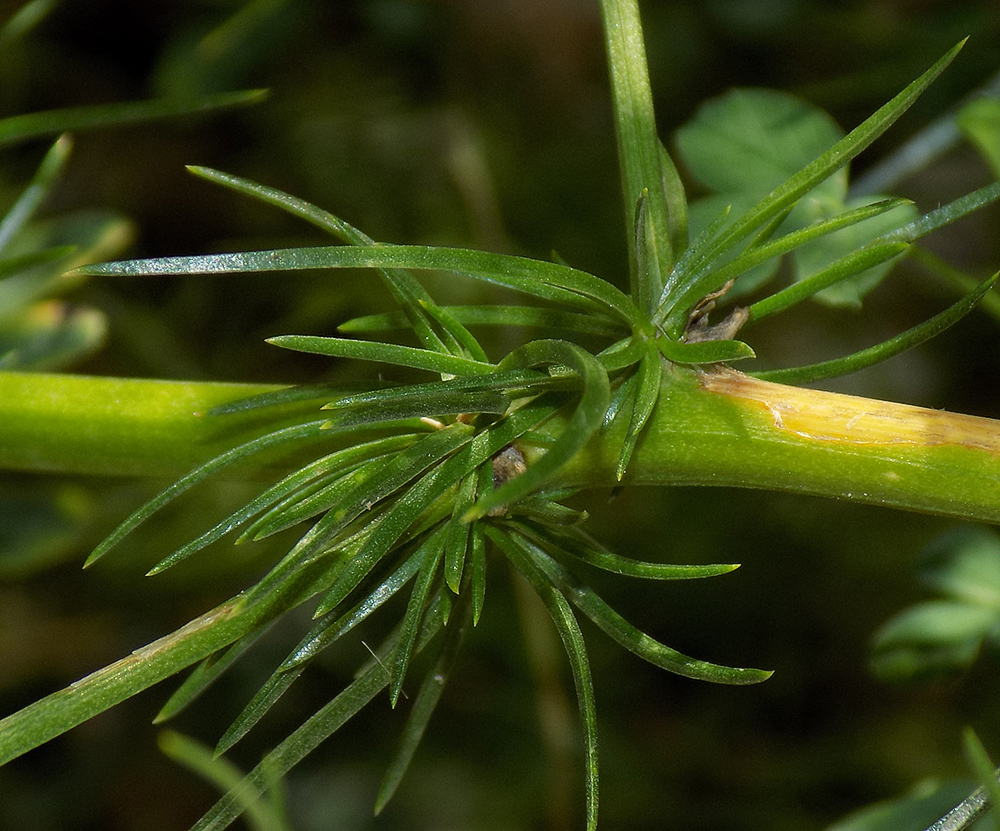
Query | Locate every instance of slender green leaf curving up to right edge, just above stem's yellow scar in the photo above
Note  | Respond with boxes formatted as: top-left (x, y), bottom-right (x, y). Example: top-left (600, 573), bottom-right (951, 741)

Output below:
top-left (750, 274), bottom-right (998, 384)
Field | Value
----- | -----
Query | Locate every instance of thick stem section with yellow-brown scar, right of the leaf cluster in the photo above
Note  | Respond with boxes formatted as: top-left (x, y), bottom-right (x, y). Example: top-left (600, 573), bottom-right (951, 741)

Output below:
top-left (554, 368), bottom-right (1000, 522)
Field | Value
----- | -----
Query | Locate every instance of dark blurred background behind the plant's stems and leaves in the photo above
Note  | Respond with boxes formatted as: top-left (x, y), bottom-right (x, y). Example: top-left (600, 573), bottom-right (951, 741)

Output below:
top-left (0, 0), bottom-right (1000, 831)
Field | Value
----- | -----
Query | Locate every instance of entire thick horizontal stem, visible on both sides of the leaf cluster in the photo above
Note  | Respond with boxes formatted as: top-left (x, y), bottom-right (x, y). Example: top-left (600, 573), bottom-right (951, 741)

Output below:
top-left (0, 367), bottom-right (1000, 522)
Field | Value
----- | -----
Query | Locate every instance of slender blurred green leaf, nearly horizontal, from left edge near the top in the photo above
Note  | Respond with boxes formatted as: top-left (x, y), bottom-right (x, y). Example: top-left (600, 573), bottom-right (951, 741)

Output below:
top-left (0, 89), bottom-right (267, 146)
